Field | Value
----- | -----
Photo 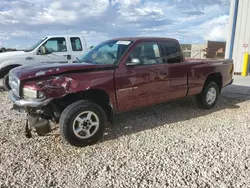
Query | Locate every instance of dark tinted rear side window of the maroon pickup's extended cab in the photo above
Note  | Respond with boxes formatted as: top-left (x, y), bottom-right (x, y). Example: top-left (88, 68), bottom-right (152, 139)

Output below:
top-left (162, 41), bottom-right (182, 64)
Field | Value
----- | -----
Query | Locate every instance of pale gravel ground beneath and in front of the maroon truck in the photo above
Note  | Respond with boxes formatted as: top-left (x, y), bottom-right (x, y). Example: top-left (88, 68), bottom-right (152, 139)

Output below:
top-left (0, 85), bottom-right (250, 188)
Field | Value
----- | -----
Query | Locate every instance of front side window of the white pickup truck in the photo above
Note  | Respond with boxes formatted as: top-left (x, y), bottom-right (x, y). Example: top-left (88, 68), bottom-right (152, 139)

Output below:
top-left (43, 37), bottom-right (67, 53)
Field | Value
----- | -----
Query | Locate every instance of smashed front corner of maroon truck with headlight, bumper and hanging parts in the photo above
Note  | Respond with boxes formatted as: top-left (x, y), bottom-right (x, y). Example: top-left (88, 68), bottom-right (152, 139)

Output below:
top-left (8, 73), bottom-right (78, 138)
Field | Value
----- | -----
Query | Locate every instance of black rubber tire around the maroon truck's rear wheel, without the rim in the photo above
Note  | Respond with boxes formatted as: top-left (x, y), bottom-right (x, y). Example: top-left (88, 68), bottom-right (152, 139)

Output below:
top-left (196, 82), bottom-right (219, 109)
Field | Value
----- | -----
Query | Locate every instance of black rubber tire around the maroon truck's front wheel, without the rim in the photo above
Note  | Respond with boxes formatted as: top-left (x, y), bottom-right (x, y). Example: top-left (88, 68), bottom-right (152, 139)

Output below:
top-left (59, 100), bottom-right (107, 147)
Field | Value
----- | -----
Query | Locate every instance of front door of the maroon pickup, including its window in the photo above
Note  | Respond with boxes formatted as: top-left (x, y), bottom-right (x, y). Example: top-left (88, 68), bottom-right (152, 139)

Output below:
top-left (115, 42), bottom-right (170, 111)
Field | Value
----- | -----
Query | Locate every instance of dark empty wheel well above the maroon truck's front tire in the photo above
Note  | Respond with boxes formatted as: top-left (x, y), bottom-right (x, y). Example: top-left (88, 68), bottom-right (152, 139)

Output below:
top-left (55, 89), bottom-right (114, 122)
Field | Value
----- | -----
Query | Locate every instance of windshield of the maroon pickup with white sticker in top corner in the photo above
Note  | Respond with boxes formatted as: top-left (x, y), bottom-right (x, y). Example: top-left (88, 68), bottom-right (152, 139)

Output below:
top-left (79, 40), bottom-right (132, 64)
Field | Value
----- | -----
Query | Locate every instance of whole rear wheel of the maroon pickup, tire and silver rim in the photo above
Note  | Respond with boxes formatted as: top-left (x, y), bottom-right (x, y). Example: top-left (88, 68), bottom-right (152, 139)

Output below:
top-left (196, 82), bottom-right (219, 109)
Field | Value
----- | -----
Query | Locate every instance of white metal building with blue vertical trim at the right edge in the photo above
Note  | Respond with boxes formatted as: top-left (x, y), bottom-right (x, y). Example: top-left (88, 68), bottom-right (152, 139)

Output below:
top-left (225, 0), bottom-right (250, 74)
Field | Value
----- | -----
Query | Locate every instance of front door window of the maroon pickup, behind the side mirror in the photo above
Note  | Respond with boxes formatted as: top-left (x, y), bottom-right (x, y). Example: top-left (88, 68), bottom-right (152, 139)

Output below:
top-left (129, 42), bottom-right (162, 65)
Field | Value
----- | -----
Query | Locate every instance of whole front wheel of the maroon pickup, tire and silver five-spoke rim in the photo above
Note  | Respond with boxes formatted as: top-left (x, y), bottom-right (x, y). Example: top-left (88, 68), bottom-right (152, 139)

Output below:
top-left (59, 100), bottom-right (106, 147)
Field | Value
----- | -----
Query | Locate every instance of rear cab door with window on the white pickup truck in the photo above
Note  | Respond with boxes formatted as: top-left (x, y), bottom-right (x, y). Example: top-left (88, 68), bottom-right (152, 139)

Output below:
top-left (70, 37), bottom-right (86, 63)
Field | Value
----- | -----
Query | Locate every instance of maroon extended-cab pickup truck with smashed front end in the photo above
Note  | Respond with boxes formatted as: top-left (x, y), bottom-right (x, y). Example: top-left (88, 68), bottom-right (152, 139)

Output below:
top-left (9, 37), bottom-right (234, 147)
